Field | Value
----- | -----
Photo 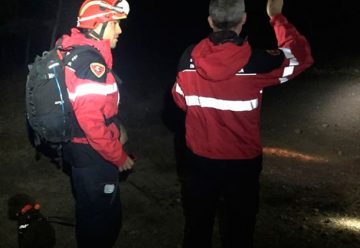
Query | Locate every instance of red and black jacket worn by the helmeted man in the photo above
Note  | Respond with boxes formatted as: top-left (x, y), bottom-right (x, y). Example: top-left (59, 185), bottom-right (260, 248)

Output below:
top-left (58, 28), bottom-right (127, 167)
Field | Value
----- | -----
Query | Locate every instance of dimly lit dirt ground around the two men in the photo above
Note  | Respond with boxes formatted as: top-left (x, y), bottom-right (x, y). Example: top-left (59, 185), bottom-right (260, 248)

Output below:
top-left (0, 49), bottom-right (360, 248)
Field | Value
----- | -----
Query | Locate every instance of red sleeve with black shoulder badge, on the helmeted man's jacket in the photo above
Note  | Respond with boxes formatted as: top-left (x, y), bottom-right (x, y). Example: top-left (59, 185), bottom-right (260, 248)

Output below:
top-left (66, 49), bottom-right (127, 167)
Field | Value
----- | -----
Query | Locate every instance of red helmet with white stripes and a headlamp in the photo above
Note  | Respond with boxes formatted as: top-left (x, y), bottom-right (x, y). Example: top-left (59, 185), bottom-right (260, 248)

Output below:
top-left (77, 0), bottom-right (130, 29)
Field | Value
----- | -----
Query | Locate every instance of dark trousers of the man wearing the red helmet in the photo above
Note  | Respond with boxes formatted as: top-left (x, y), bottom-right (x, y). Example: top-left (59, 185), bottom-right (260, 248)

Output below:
top-left (63, 143), bottom-right (121, 248)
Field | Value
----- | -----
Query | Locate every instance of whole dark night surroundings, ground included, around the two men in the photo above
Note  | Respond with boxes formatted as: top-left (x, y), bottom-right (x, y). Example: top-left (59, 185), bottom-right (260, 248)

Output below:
top-left (0, 0), bottom-right (360, 248)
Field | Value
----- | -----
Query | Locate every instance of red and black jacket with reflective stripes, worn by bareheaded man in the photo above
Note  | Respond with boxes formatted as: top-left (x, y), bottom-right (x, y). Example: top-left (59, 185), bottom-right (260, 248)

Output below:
top-left (172, 14), bottom-right (313, 159)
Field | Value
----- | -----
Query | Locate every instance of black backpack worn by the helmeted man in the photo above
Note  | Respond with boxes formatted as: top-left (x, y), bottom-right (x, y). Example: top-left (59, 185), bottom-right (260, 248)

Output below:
top-left (25, 40), bottom-right (96, 165)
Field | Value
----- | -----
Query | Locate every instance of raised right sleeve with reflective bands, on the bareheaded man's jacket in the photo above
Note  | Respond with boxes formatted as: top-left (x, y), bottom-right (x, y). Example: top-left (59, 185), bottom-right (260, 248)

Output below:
top-left (262, 14), bottom-right (314, 87)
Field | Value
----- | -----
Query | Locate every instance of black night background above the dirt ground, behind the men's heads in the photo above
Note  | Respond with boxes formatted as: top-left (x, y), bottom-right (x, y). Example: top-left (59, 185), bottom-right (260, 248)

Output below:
top-left (0, 0), bottom-right (359, 75)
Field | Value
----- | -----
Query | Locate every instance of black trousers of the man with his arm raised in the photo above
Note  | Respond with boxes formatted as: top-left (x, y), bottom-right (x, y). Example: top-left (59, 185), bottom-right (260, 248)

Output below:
top-left (182, 150), bottom-right (262, 248)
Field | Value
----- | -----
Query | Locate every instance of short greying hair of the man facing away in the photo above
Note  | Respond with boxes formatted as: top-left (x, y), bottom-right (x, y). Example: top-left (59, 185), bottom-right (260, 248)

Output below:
top-left (209, 0), bottom-right (245, 30)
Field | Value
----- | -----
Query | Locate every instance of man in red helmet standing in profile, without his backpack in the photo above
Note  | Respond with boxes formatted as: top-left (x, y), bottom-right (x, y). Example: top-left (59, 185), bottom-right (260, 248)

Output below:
top-left (61, 0), bottom-right (134, 248)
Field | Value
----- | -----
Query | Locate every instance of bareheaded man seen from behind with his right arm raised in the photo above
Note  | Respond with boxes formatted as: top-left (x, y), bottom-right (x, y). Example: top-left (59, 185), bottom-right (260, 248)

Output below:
top-left (172, 0), bottom-right (313, 248)
